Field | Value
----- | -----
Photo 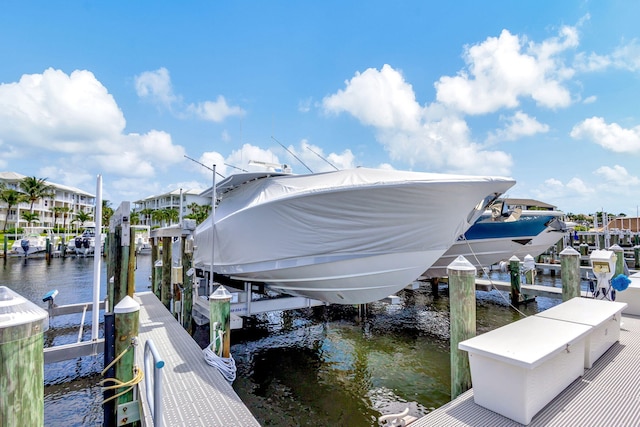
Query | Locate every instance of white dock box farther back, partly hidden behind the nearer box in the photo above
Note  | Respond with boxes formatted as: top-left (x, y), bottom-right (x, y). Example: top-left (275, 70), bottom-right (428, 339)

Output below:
top-left (536, 297), bottom-right (627, 368)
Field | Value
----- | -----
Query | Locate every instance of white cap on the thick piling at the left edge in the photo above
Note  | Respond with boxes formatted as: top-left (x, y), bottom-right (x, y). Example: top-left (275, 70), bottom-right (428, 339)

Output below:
top-left (0, 286), bottom-right (49, 338)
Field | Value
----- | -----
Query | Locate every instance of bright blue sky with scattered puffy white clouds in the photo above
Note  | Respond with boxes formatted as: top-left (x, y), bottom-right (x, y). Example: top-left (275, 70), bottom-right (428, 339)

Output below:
top-left (0, 0), bottom-right (640, 216)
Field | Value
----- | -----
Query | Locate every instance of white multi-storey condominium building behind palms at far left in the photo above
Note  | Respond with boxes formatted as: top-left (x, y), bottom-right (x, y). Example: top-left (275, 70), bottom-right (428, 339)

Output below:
top-left (0, 172), bottom-right (96, 229)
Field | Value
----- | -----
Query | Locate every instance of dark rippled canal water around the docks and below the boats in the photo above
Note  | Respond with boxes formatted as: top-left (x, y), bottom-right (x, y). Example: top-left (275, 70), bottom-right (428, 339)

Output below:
top-left (0, 255), bottom-right (561, 427)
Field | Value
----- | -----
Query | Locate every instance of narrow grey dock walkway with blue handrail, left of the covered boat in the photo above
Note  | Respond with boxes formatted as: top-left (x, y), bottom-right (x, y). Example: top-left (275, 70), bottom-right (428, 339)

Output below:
top-left (135, 292), bottom-right (260, 427)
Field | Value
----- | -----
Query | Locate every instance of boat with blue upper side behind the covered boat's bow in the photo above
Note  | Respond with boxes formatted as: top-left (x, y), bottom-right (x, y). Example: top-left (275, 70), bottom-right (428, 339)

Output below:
top-left (422, 208), bottom-right (567, 278)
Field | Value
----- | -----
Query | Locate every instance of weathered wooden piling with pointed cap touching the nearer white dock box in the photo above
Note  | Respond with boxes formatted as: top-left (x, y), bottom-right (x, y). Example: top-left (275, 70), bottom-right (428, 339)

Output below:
top-left (447, 256), bottom-right (477, 400)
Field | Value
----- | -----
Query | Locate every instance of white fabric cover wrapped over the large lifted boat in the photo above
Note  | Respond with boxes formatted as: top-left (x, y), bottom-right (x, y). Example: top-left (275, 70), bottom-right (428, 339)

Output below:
top-left (194, 168), bottom-right (515, 274)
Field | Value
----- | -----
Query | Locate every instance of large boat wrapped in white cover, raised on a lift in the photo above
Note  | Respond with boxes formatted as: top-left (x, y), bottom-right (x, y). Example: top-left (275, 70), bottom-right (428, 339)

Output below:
top-left (194, 168), bottom-right (515, 304)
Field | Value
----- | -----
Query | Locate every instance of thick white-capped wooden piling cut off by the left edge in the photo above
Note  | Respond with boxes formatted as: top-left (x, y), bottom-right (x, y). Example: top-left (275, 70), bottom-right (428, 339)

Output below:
top-left (0, 286), bottom-right (49, 427)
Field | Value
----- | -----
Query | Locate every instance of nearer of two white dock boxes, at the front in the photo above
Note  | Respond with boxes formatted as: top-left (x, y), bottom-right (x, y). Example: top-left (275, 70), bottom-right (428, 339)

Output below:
top-left (458, 316), bottom-right (591, 425)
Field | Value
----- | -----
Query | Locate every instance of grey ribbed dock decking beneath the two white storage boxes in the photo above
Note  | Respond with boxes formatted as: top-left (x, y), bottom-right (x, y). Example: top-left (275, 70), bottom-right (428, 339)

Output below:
top-left (411, 315), bottom-right (640, 427)
